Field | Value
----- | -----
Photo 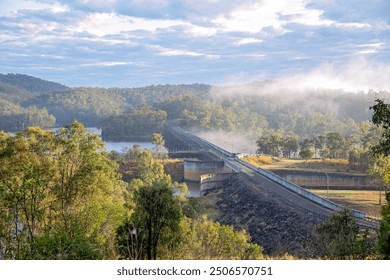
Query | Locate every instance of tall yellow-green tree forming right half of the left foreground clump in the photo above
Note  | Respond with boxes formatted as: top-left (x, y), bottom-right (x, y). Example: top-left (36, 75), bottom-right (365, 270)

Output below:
top-left (54, 122), bottom-right (125, 254)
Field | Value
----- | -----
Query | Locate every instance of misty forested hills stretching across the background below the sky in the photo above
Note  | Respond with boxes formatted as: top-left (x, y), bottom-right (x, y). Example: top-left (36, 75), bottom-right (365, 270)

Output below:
top-left (0, 74), bottom-right (390, 141)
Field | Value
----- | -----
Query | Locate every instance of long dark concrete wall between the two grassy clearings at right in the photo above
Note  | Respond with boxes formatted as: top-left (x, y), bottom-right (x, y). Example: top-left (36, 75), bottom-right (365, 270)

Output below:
top-left (270, 169), bottom-right (377, 190)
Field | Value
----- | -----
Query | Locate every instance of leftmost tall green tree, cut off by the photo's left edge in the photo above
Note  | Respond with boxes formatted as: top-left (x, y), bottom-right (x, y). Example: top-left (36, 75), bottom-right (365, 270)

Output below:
top-left (0, 128), bottom-right (54, 259)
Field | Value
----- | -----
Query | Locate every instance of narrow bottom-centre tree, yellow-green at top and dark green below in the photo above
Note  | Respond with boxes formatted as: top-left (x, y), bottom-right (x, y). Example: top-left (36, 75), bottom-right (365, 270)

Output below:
top-left (117, 150), bottom-right (182, 260)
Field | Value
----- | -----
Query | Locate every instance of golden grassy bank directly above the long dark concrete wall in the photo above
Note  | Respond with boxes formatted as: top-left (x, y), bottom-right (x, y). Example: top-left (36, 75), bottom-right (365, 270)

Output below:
top-left (243, 156), bottom-right (361, 174)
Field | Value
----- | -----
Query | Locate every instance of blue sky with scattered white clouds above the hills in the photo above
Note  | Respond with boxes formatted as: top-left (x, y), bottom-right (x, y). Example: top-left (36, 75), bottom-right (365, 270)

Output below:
top-left (0, 0), bottom-right (390, 90)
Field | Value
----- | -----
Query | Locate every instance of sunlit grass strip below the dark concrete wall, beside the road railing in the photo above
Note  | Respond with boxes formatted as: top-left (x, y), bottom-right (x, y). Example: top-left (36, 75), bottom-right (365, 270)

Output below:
top-left (310, 190), bottom-right (386, 219)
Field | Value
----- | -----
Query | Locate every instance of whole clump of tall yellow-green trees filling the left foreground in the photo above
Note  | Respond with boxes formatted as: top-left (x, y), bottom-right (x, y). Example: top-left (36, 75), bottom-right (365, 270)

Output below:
top-left (0, 122), bottom-right (125, 259)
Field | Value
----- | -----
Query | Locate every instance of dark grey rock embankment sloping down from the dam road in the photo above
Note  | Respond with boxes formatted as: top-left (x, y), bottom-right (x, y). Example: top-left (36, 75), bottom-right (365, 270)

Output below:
top-left (203, 173), bottom-right (324, 258)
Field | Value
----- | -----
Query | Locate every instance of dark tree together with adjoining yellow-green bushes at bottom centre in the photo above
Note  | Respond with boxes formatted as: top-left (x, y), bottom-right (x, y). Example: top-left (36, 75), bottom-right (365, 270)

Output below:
top-left (117, 150), bottom-right (262, 259)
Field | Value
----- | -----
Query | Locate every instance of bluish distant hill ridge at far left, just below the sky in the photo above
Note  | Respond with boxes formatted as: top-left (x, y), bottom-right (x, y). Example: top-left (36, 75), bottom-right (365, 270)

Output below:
top-left (0, 74), bottom-right (68, 94)
